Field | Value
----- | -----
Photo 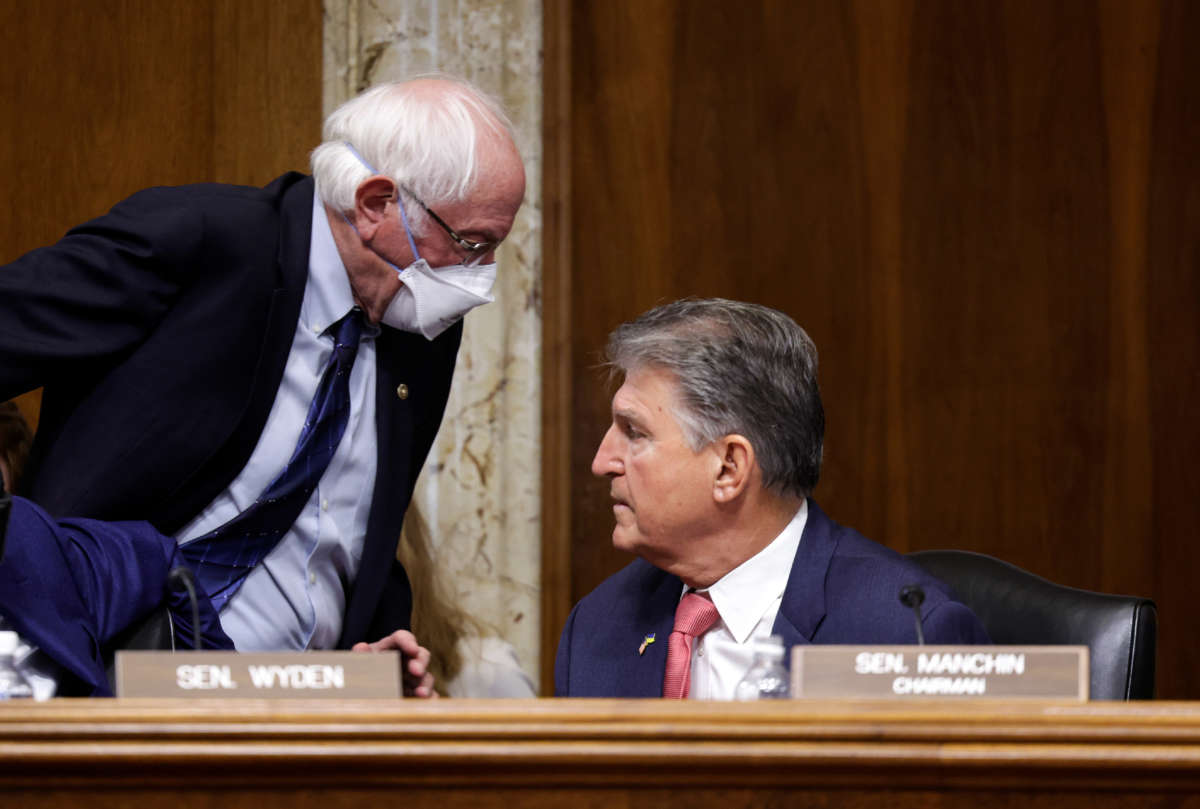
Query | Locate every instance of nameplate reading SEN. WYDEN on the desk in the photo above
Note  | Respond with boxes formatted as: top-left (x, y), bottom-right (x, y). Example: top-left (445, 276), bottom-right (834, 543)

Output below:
top-left (116, 652), bottom-right (402, 700)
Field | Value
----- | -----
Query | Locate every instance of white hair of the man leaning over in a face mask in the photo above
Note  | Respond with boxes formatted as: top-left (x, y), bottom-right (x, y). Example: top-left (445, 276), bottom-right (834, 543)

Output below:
top-left (310, 76), bottom-right (515, 232)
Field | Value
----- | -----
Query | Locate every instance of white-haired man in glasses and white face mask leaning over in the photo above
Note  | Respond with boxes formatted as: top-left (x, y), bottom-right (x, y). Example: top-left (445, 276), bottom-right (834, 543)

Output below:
top-left (0, 77), bottom-right (524, 694)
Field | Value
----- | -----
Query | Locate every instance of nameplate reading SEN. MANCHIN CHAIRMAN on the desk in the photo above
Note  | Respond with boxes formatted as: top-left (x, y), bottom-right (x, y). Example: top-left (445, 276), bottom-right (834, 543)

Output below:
top-left (792, 646), bottom-right (1088, 701)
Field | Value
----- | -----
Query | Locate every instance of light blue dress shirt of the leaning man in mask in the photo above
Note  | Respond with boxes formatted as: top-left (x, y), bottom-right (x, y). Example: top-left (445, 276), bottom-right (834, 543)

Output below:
top-left (175, 194), bottom-right (379, 652)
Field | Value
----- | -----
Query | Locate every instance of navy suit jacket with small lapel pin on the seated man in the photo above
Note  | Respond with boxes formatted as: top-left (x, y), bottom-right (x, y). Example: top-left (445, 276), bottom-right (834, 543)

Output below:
top-left (554, 499), bottom-right (989, 696)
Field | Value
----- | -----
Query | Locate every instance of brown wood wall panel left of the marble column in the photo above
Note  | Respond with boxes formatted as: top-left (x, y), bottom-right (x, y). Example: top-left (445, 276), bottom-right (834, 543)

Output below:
top-left (0, 0), bottom-right (322, 465)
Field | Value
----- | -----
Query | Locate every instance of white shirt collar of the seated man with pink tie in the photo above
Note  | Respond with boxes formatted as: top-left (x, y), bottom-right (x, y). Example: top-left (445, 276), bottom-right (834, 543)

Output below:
top-left (704, 498), bottom-right (809, 643)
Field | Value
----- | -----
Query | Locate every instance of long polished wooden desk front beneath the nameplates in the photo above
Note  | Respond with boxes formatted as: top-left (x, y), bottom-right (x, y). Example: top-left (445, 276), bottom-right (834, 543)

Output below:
top-left (0, 700), bottom-right (1200, 809)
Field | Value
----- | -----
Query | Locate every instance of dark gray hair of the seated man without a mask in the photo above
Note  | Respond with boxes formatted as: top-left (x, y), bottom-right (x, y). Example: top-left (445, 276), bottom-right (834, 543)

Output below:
top-left (607, 298), bottom-right (824, 497)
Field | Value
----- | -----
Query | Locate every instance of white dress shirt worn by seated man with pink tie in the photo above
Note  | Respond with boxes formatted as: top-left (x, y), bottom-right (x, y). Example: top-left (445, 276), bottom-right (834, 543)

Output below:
top-left (679, 499), bottom-right (809, 700)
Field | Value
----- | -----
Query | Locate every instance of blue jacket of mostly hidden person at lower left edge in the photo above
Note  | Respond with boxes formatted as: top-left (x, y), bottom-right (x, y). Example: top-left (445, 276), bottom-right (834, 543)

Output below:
top-left (0, 497), bottom-right (233, 696)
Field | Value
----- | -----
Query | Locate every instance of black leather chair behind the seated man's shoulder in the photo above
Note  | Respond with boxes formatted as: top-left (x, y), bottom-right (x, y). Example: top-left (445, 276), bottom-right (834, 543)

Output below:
top-left (908, 551), bottom-right (1158, 700)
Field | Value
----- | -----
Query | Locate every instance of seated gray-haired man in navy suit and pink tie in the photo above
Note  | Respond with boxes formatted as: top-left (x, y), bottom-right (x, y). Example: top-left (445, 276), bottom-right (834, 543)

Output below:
top-left (554, 299), bottom-right (988, 699)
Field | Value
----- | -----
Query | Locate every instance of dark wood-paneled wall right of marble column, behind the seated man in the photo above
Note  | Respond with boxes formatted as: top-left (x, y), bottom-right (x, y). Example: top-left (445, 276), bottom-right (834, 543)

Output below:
top-left (544, 0), bottom-right (1200, 697)
